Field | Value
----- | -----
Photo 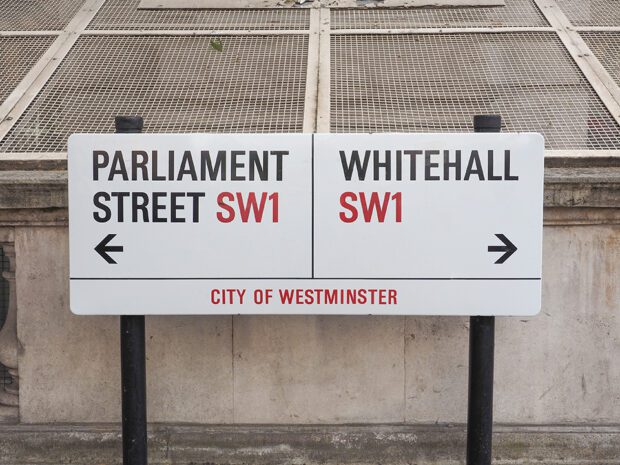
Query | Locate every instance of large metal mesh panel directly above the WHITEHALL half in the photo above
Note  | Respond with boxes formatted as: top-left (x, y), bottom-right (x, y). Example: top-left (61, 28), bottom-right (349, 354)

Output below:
top-left (331, 33), bottom-right (620, 149)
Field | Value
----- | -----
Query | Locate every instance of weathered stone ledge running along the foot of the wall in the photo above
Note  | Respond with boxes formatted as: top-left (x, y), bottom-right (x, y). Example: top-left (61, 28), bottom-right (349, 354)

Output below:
top-left (0, 424), bottom-right (620, 465)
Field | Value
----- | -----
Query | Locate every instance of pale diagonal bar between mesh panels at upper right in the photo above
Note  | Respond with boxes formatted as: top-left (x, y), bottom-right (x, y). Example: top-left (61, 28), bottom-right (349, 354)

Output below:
top-left (534, 0), bottom-right (620, 124)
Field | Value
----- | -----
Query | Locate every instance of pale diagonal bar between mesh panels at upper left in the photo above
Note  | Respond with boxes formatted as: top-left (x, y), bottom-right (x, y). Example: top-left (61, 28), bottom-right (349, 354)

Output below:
top-left (0, 0), bottom-right (105, 141)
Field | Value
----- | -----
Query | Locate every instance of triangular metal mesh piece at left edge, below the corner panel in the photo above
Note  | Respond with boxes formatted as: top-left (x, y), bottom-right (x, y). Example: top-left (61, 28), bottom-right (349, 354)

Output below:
top-left (0, 36), bottom-right (56, 104)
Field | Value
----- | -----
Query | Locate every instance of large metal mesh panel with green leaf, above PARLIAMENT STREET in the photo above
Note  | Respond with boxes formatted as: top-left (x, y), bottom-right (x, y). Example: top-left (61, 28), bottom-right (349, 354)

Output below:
top-left (0, 35), bottom-right (308, 152)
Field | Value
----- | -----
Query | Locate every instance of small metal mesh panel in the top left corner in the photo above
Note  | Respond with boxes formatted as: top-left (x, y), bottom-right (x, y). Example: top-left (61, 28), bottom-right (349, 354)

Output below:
top-left (0, 0), bottom-right (84, 31)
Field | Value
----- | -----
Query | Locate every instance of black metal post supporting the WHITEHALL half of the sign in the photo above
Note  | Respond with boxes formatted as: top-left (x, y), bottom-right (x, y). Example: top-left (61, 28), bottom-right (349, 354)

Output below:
top-left (467, 115), bottom-right (502, 465)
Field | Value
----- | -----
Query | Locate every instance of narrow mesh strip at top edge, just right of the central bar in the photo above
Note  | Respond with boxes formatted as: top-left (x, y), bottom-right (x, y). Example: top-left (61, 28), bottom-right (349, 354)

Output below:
top-left (331, 0), bottom-right (549, 29)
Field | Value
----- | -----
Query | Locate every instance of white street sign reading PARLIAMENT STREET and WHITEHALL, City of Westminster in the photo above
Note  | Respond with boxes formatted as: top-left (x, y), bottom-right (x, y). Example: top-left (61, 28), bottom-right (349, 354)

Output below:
top-left (68, 133), bottom-right (544, 315)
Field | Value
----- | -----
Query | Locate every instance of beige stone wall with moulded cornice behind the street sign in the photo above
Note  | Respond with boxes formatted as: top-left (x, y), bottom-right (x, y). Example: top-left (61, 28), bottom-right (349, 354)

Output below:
top-left (0, 159), bottom-right (620, 425)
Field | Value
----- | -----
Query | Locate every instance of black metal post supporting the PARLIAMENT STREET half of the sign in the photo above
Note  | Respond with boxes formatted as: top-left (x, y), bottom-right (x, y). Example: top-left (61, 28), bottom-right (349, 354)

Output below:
top-left (114, 116), bottom-right (147, 465)
